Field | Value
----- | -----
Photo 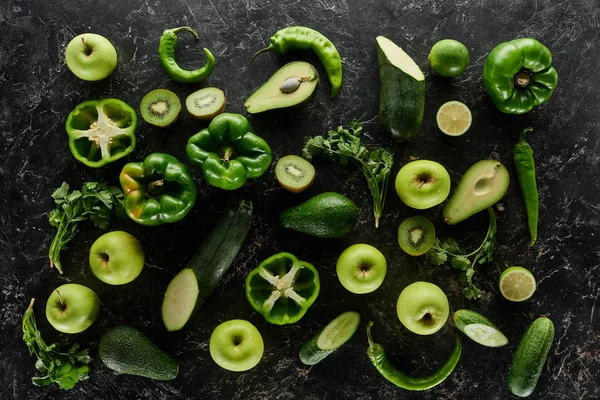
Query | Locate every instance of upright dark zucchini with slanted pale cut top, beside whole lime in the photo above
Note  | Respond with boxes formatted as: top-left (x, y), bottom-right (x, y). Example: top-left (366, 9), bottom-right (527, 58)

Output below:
top-left (377, 36), bottom-right (425, 141)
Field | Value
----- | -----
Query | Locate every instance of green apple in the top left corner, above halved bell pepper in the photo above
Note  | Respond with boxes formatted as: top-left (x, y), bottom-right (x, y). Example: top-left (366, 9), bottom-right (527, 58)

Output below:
top-left (65, 33), bottom-right (117, 81)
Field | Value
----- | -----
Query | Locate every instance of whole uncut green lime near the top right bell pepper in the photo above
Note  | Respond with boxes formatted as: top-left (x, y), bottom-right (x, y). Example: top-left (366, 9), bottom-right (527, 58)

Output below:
top-left (427, 39), bottom-right (469, 78)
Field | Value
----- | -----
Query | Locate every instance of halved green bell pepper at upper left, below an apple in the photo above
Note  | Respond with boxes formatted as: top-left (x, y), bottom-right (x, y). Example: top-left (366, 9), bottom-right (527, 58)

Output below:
top-left (65, 99), bottom-right (137, 168)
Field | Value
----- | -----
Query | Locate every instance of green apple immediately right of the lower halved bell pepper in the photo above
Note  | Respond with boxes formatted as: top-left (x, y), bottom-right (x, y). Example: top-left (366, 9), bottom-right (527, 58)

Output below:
top-left (336, 244), bottom-right (387, 294)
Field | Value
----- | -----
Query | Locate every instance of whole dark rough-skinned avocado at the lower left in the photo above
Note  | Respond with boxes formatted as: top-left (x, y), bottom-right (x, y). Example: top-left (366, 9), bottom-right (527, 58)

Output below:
top-left (98, 325), bottom-right (179, 381)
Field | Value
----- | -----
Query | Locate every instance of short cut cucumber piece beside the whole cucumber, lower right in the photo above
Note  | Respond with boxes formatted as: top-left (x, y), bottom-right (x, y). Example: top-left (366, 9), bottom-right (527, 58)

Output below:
top-left (454, 309), bottom-right (508, 347)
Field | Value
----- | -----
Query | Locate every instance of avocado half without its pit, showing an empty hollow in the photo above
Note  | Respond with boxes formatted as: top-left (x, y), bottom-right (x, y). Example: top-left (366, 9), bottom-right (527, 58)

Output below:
top-left (443, 160), bottom-right (510, 225)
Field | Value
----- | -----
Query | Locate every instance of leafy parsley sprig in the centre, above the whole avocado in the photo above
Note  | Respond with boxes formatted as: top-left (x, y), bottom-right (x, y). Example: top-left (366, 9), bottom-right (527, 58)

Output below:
top-left (302, 121), bottom-right (394, 227)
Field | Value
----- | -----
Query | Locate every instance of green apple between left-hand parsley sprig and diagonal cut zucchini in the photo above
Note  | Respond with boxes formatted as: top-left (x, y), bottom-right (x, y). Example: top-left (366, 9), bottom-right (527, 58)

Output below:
top-left (90, 231), bottom-right (144, 285)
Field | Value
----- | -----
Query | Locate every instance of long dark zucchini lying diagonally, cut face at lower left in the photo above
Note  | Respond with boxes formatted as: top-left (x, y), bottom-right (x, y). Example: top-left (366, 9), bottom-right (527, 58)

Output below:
top-left (162, 200), bottom-right (252, 331)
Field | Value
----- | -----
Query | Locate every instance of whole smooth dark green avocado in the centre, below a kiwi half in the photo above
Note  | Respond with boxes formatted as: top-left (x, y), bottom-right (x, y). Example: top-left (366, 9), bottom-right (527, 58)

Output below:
top-left (279, 192), bottom-right (358, 238)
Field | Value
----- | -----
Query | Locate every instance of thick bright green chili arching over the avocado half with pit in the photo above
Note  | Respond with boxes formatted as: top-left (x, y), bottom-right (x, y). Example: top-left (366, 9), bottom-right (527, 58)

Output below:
top-left (250, 26), bottom-right (342, 98)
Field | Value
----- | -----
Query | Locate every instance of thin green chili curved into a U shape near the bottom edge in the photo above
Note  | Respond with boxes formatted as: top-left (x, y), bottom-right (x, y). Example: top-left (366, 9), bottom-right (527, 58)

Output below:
top-left (367, 321), bottom-right (462, 390)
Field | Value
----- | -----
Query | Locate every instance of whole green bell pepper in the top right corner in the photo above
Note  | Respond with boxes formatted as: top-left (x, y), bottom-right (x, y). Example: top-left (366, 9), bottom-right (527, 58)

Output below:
top-left (483, 38), bottom-right (558, 114)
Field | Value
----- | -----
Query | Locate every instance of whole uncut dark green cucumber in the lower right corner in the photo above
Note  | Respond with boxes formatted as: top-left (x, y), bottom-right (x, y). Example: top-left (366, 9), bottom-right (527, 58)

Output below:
top-left (508, 317), bottom-right (554, 397)
